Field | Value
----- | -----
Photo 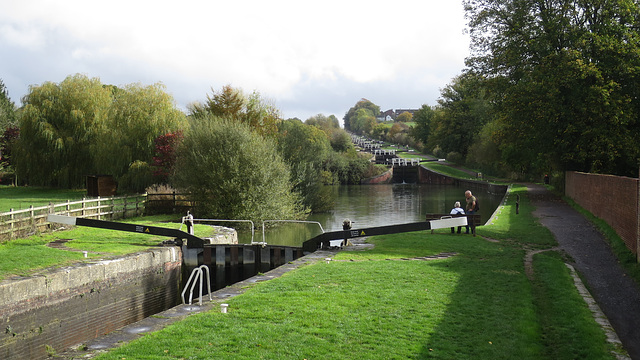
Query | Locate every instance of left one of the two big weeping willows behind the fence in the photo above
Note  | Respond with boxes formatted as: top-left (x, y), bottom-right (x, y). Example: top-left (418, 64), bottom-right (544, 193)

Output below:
top-left (14, 75), bottom-right (111, 188)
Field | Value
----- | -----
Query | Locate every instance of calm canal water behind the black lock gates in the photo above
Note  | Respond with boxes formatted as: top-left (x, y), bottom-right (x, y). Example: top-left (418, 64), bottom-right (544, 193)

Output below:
top-left (238, 184), bottom-right (504, 246)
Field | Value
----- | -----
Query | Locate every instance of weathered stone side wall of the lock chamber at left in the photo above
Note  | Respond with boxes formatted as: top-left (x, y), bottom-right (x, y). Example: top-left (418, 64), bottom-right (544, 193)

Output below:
top-left (0, 247), bottom-right (182, 360)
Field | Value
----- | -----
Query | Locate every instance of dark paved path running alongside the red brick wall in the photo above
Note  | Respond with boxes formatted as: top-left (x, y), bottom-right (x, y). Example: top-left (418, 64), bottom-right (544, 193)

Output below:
top-left (528, 185), bottom-right (640, 360)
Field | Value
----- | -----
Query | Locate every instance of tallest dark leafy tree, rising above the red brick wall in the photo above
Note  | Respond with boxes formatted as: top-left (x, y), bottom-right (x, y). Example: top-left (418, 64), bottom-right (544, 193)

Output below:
top-left (465, 0), bottom-right (640, 175)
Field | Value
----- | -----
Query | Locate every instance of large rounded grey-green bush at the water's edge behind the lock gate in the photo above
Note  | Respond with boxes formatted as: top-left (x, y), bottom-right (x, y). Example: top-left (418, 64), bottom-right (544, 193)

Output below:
top-left (172, 115), bottom-right (306, 222)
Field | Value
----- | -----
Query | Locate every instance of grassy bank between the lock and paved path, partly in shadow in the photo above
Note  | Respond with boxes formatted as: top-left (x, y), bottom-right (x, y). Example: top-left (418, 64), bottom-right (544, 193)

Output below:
top-left (92, 187), bottom-right (615, 360)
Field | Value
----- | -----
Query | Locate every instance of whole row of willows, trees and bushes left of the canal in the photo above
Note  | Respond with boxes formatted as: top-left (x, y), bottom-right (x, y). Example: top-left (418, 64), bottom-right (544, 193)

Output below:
top-left (0, 74), bottom-right (372, 221)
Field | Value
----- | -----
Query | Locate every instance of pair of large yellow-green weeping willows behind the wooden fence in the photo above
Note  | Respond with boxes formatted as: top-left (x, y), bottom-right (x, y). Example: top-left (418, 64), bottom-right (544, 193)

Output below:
top-left (14, 74), bottom-right (186, 191)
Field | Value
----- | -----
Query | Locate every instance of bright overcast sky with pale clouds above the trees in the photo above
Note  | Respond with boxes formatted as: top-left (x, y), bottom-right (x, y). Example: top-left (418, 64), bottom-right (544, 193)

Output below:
top-left (0, 0), bottom-right (469, 120)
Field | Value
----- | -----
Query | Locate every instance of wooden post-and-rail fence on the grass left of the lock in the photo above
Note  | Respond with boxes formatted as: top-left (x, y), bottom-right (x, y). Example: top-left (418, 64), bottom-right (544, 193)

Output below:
top-left (0, 194), bottom-right (147, 241)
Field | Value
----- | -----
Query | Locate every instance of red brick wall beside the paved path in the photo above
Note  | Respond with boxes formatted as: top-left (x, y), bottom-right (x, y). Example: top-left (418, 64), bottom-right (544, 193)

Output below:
top-left (565, 171), bottom-right (640, 254)
